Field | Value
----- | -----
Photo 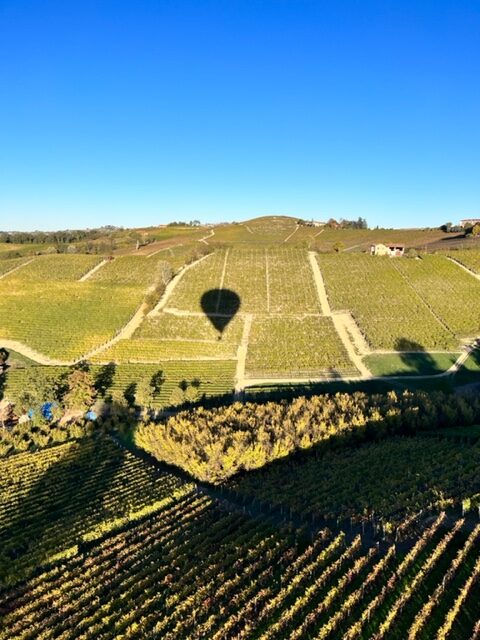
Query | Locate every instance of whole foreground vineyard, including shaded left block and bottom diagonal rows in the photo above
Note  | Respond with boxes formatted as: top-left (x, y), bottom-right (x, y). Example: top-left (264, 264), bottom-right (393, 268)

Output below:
top-left (0, 432), bottom-right (480, 640)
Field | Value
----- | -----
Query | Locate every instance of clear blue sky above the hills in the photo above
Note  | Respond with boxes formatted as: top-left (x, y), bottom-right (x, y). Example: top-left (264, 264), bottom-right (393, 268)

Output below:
top-left (0, 0), bottom-right (480, 229)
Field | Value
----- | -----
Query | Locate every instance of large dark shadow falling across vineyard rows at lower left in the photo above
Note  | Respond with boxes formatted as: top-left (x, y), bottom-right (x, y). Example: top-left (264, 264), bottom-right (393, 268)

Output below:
top-left (0, 412), bottom-right (125, 586)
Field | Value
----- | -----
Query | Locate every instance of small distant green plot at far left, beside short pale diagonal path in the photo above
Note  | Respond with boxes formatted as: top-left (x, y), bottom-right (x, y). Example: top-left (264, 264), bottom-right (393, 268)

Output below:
top-left (7, 255), bottom-right (102, 283)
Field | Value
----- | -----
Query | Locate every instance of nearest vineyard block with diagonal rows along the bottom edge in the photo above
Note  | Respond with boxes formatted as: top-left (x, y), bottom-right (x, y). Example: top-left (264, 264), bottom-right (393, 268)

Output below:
top-left (0, 495), bottom-right (480, 640)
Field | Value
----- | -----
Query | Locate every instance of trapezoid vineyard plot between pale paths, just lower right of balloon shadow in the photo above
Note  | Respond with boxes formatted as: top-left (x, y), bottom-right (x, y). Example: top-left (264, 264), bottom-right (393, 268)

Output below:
top-left (246, 316), bottom-right (358, 378)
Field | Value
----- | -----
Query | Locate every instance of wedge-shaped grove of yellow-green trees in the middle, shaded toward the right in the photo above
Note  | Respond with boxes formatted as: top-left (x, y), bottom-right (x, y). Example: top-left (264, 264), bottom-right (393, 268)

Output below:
top-left (135, 392), bottom-right (480, 482)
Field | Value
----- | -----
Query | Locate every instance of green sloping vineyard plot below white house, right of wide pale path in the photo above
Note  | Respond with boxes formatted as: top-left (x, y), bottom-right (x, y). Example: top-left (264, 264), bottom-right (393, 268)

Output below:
top-left (318, 253), bottom-right (458, 351)
